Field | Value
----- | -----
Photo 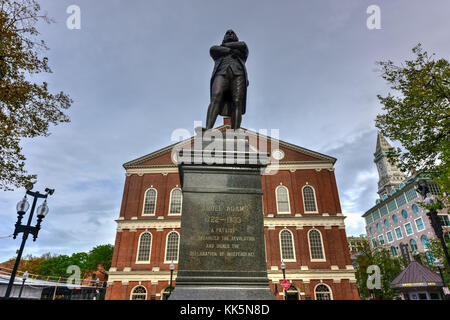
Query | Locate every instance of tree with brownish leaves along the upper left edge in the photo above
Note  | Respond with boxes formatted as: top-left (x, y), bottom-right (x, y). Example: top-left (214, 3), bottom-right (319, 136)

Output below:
top-left (0, 0), bottom-right (72, 190)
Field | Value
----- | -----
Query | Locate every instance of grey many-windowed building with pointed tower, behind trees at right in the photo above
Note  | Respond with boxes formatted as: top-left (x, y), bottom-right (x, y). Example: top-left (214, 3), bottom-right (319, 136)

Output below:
top-left (363, 134), bottom-right (450, 257)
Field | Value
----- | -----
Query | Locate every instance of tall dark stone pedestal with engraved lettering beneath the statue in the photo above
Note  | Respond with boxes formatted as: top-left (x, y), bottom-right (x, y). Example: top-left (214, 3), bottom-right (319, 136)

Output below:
top-left (169, 129), bottom-right (275, 300)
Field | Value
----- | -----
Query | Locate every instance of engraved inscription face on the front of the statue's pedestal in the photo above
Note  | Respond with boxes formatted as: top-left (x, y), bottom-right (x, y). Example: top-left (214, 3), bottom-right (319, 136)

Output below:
top-left (178, 193), bottom-right (265, 272)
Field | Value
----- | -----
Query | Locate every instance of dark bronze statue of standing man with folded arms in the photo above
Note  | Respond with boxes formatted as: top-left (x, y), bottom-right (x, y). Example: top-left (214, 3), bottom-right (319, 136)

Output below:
top-left (206, 30), bottom-right (248, 130)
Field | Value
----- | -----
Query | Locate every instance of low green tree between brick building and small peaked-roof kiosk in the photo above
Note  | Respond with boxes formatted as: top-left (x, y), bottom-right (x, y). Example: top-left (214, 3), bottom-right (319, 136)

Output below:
top-left (356, 247), bottom-right (406, 300)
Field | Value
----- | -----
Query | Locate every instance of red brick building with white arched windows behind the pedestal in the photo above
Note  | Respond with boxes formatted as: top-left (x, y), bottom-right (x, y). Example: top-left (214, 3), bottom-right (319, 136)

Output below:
top-left (106, 122), bottom-right (359, 300)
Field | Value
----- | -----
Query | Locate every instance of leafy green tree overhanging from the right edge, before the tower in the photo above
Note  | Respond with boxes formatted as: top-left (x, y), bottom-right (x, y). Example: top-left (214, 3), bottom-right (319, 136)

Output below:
top-left (375, 43), bottom-right (450, 191)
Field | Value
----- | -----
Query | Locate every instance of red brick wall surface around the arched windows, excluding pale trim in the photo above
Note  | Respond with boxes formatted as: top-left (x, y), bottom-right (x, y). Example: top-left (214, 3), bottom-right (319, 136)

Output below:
top-left (107, 146), bottom-right (358, 299)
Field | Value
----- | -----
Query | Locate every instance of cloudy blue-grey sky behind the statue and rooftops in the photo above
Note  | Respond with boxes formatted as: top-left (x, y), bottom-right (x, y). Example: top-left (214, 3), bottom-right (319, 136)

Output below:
top-left (0, 0), bottom-right (450, 261)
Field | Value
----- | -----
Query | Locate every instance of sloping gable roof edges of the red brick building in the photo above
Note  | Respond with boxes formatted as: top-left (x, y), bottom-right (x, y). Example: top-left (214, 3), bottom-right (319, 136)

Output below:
top-left (123, 125), bottom-right (337, 169)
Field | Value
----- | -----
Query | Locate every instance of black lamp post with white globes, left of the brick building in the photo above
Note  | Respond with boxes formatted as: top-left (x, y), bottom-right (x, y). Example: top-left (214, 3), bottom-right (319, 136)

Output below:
top-left (4, 188), bottom-right (55, 299)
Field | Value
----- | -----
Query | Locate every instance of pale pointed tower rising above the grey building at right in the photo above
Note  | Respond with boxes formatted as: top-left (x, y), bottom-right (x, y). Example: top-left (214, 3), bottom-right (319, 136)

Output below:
top-left (374, 133), bottom-right (406, 198)
